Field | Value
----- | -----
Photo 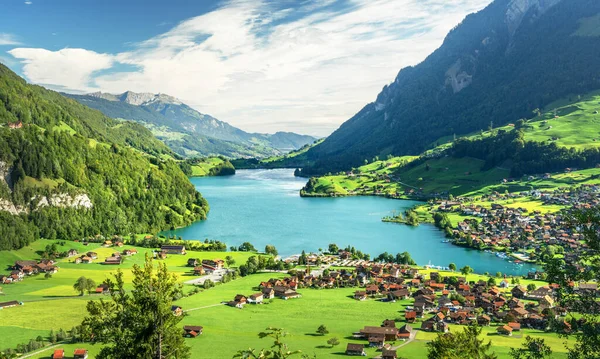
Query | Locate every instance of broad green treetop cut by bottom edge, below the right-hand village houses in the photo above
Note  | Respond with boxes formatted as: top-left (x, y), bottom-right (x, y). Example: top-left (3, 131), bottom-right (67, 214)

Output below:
top-left (427, 326), bottom-right (497, 359)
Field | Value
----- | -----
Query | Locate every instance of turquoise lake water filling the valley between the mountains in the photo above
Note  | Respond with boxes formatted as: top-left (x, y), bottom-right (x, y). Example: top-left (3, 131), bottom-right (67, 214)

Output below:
top-left (164, 169), bottom-right (533, 274)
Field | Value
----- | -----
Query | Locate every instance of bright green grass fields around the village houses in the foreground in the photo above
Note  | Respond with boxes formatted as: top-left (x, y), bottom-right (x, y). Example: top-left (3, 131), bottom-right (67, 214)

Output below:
top-left (0, 240), bottom-right (566, 358)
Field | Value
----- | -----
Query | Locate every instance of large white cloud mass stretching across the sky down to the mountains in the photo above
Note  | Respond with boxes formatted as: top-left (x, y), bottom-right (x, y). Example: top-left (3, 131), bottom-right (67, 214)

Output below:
top-left (11, 0), bottom-right (490, 135)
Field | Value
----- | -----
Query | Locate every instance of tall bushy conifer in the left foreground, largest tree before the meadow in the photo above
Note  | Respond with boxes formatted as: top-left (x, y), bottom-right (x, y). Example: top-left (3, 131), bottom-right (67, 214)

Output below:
top-left (83, 255), bottom-right (190, 359)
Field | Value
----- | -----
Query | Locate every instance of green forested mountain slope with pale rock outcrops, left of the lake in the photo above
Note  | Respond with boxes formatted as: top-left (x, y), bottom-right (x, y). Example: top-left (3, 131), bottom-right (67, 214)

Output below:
top-left (0, 64), bottom-right (208, 249)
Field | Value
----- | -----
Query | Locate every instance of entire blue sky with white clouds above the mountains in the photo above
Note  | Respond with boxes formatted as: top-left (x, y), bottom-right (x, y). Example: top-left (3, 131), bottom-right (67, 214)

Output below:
top-left (0, 0), bottom-right (491, 136)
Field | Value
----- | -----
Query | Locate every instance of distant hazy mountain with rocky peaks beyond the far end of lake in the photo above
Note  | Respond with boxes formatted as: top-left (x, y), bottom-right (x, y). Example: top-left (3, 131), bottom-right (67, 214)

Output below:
top-left (67, 91), bottom-right (315, 157)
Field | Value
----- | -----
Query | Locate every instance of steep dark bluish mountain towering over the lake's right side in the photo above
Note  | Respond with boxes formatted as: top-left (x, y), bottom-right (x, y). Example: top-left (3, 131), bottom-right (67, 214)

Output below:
top-left (304, 0), bottom-right (600, 175)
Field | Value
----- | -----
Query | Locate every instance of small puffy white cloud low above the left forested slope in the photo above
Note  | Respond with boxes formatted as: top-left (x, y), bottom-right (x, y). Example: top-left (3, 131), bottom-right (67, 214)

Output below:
top-left (8, 48), bottom-right (114, 91)
